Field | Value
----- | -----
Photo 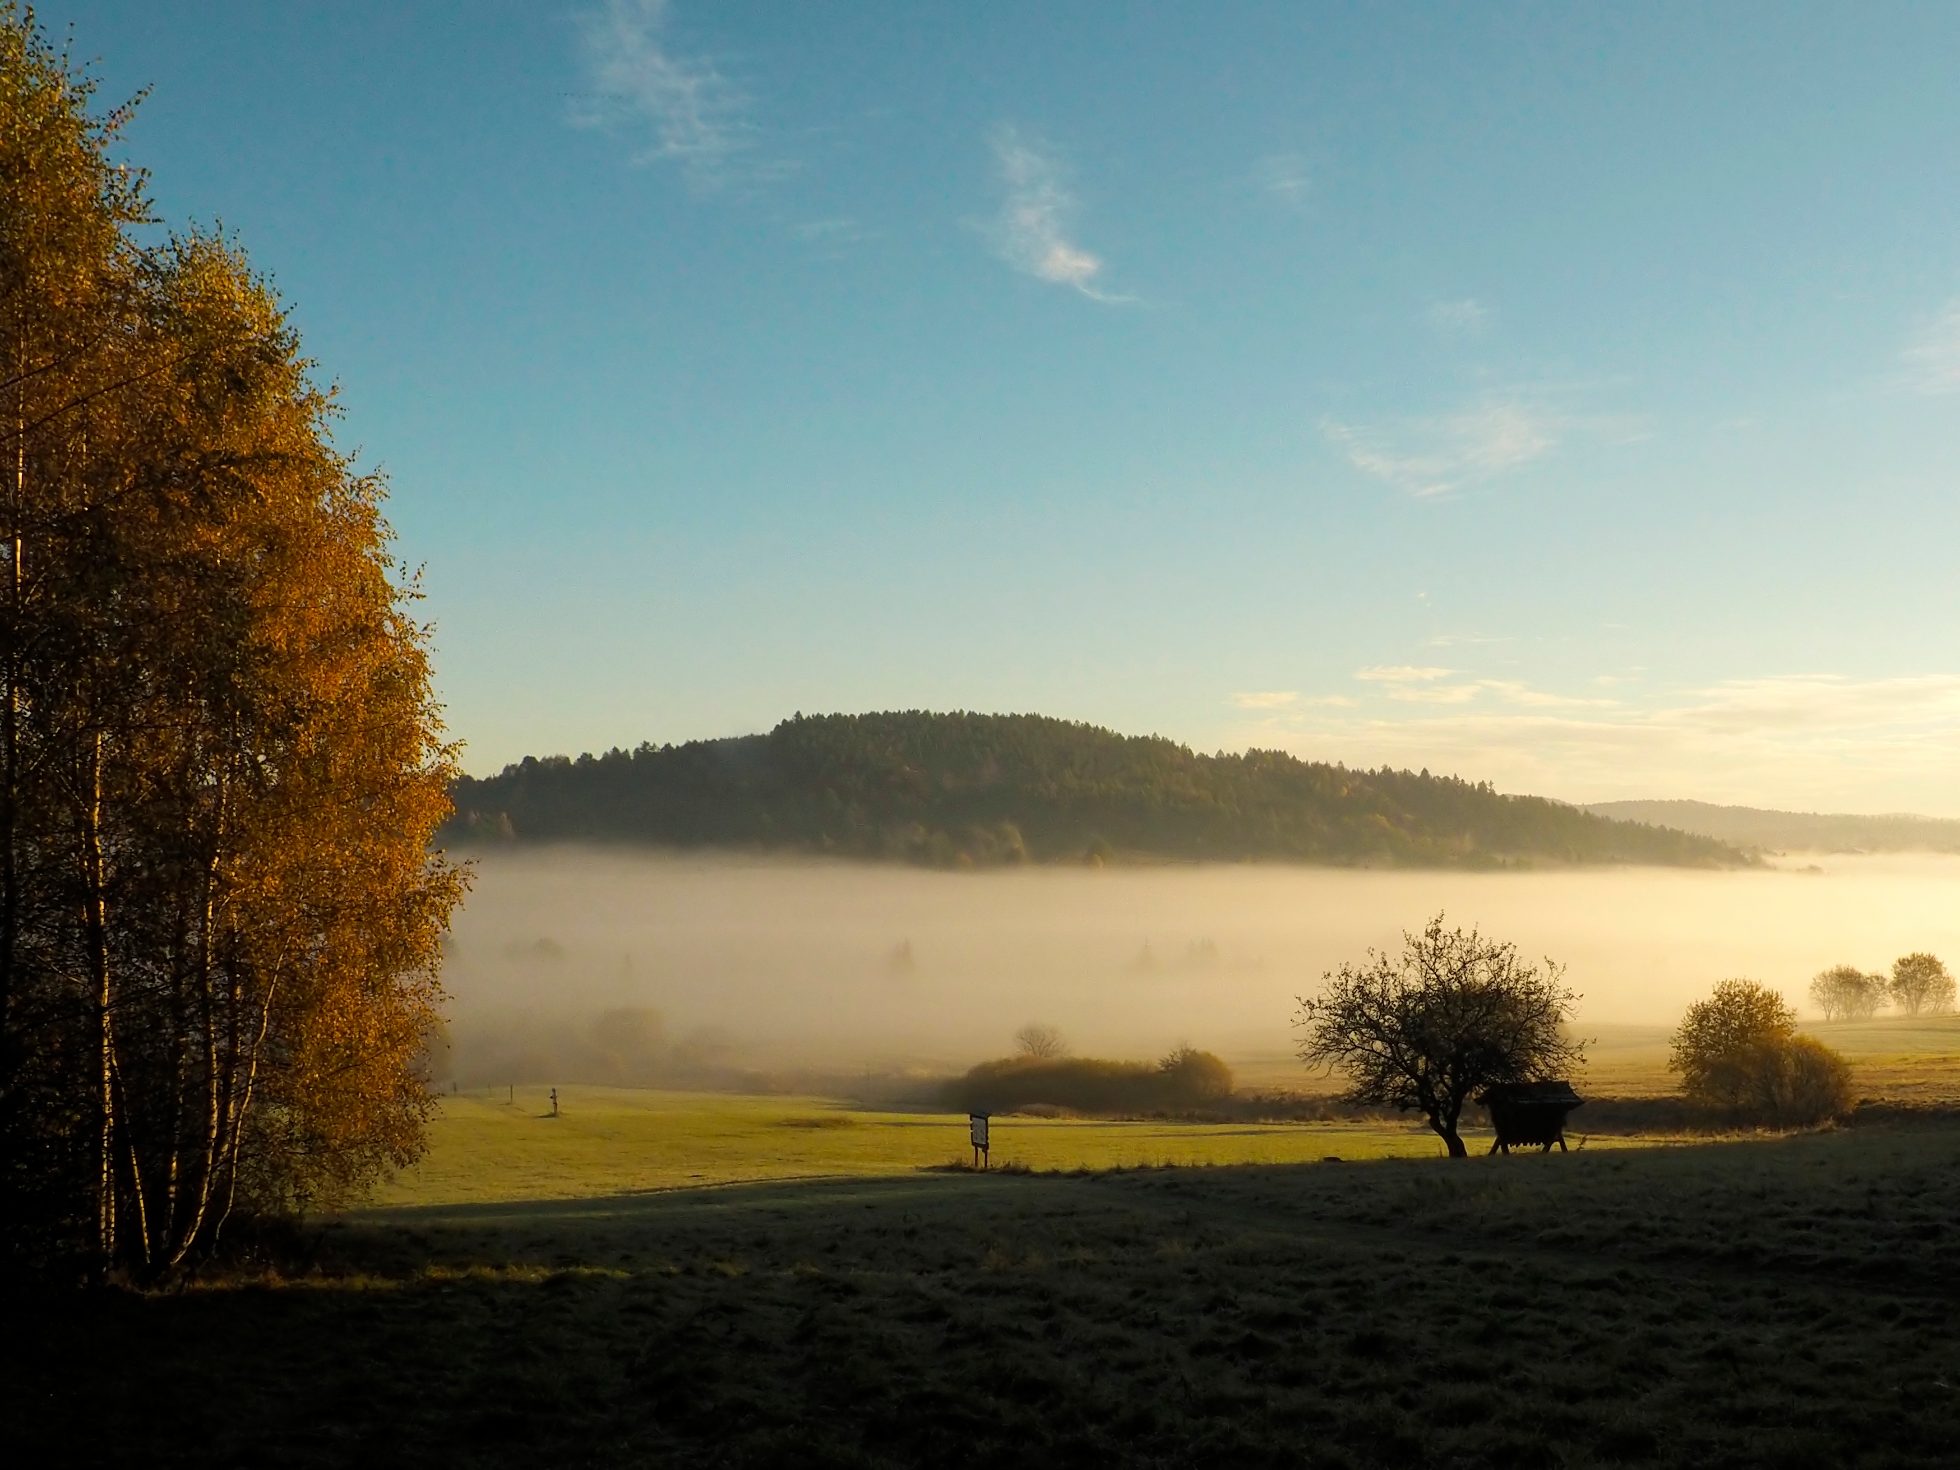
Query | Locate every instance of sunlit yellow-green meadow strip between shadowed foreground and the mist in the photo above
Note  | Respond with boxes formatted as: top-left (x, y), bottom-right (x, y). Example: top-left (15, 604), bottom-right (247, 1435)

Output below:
top-left (374, 1088), bottom-right (1669, 1207)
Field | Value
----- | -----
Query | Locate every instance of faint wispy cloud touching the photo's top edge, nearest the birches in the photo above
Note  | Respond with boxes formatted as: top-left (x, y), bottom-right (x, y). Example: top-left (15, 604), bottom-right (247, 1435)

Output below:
top-left (572, 0), bottom-right (784, 188)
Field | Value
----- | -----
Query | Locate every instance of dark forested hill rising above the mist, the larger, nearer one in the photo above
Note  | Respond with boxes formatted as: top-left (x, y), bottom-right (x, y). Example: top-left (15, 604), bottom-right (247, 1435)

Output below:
top-left (445, 711), bottom-right (1748, 868)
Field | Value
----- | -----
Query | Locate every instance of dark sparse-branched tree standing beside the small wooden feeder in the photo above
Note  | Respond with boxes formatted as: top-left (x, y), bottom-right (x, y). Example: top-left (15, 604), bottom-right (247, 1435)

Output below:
top-left (1294, 913), bottom-right (1586, 1158)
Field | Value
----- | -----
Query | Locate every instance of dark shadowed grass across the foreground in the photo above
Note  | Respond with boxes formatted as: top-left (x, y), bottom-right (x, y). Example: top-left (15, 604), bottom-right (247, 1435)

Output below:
top-left (4, 1127), bottom-right (1960, 1470)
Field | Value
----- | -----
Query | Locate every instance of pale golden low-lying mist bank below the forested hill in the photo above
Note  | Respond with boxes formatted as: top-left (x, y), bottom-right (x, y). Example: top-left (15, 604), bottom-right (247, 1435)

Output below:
top-left (443, 847), bottom-right (1960, 1084)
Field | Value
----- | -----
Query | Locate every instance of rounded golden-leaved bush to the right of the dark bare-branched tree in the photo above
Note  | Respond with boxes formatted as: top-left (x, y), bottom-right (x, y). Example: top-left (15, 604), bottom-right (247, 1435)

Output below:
top-left (1668, 980), bottom-right (1850, 1125)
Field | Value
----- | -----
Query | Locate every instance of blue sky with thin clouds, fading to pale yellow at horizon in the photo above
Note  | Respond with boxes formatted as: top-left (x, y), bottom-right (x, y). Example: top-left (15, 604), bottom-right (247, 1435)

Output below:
top-left (53, 0), bottom-right (1960, 815)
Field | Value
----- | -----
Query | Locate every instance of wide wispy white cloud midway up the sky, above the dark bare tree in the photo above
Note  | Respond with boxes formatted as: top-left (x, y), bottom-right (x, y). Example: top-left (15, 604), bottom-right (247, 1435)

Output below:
top-left (1321, 398), bottom-right (1562, 500)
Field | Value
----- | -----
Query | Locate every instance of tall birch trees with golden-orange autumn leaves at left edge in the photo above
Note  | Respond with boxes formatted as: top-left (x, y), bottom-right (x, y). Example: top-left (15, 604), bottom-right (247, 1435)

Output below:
top-left (0, 6), bottom-right (463, 1278)
